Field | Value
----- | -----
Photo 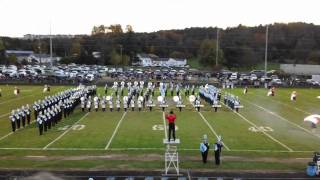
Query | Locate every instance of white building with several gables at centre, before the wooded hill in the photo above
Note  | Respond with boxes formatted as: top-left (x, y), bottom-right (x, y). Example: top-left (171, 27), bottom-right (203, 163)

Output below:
top-left (137, 54), bottom-right (187, 67)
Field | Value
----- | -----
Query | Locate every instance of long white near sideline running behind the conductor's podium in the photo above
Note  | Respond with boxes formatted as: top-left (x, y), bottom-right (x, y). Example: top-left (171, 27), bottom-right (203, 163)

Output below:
top-left (0, 147), bottom-right (314, 153)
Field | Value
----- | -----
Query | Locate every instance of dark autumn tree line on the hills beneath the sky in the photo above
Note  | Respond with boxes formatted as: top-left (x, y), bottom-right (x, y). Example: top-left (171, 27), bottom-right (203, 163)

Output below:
top-left (0, 22), bottom-right (320, 68)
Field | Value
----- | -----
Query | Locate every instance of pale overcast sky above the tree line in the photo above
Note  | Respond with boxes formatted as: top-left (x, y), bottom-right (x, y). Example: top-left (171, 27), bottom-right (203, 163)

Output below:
top-left (0, 0), bottom-right (320, 37)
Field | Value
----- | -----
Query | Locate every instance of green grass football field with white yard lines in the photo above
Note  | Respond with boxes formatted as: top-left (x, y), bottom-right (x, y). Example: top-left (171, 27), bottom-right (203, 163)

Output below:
top-left (0, 86), bottom-right (320, 171)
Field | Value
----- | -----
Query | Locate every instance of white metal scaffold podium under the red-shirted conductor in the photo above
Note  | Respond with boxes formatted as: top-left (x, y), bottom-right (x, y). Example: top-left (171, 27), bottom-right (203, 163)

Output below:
top-left (163, 139), bottom-right (180, 176)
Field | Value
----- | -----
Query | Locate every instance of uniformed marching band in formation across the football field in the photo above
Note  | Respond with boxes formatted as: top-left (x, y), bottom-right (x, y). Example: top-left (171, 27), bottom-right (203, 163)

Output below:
top-left (5, 81), bottom-right (245, 135)
